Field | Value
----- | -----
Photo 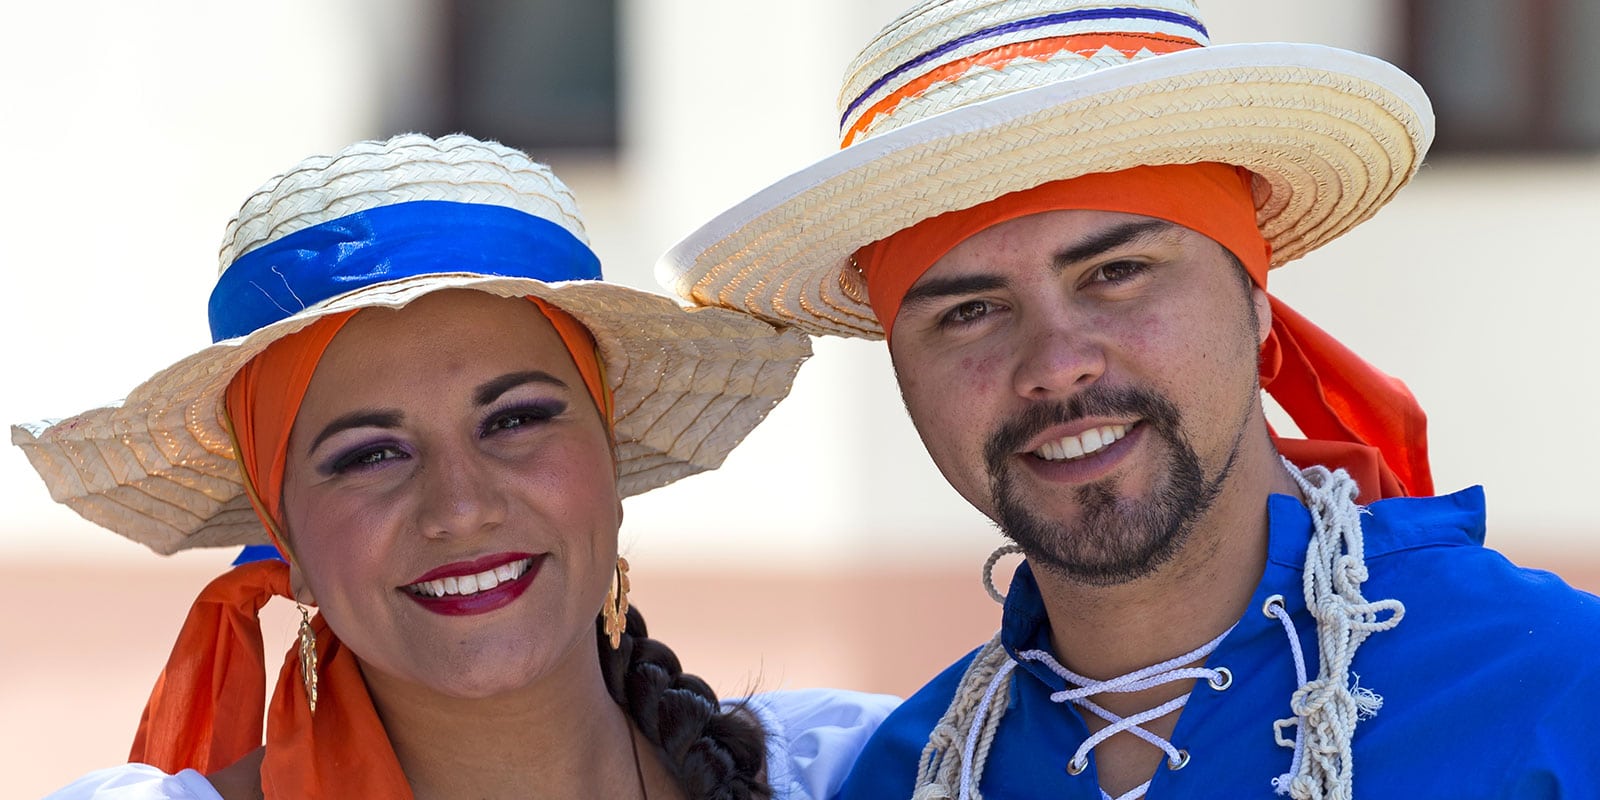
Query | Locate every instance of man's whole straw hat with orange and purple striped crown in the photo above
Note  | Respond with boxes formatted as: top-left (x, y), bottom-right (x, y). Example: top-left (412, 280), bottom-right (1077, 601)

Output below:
top-left (658, 0), bottom-right (1434, 338)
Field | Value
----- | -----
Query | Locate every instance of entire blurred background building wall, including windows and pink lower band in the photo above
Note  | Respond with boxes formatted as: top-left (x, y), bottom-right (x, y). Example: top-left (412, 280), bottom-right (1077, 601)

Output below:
top-left (0, 0), bottom-right (1600, 797)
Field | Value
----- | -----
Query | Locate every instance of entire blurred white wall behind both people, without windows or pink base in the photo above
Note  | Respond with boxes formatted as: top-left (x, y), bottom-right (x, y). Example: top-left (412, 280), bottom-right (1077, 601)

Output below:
top-left (0, 0), bottom-right (1600, 568)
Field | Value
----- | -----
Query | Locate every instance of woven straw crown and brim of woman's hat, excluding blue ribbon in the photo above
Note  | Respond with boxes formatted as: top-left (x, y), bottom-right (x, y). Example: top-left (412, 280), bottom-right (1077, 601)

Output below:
top-left (11, 134), bottom-right (810, 554)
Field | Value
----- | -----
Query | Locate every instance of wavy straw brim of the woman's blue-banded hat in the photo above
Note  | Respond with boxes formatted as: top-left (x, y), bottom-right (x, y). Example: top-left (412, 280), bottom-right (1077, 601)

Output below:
top-left (11, 274), bottom-right (811, 554)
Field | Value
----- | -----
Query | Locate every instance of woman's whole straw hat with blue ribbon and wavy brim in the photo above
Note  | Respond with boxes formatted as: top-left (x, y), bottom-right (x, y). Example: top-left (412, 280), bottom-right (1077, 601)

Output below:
top-left (11, 134), bottom-right (810, 554)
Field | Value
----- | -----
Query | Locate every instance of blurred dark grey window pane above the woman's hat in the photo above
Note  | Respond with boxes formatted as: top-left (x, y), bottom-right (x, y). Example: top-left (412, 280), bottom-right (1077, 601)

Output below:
top-left (442, 0), bottom-right (618, 150)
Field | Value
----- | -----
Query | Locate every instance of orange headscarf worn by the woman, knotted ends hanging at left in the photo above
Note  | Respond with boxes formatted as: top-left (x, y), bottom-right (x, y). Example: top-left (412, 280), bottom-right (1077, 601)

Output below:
top-left (128, 298), bottom-right (611, 798)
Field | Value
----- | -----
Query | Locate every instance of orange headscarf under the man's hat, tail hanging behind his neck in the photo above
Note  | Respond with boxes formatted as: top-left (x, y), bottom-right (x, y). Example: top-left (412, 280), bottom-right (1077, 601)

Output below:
top-left (856, 163), bottom-right (1434, 502)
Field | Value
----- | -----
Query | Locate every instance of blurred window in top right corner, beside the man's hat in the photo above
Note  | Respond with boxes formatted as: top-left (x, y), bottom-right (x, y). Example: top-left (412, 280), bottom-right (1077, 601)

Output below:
top-left (1405, 0), bottom-right (1600, 152)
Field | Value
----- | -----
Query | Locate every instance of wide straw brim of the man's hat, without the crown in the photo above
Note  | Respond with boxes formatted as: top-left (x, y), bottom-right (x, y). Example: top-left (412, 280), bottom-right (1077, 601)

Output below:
top-left (656, 43), bottom-right (1434, 338)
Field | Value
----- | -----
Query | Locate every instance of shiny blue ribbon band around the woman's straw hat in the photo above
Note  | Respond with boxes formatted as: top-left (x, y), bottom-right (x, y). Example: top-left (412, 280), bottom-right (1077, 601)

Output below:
top-left (210, 200), bottom-right (602, 342)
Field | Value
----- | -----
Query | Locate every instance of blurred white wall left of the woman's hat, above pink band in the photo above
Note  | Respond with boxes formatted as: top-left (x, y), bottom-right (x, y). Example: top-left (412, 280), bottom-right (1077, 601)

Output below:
top-left (0, 0), bottom-right (406, 557)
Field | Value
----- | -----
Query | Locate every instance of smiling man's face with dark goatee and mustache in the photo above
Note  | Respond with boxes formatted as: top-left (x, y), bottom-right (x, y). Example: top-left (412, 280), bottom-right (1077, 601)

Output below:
top-left (890, 211), bottom-right (1269, 584)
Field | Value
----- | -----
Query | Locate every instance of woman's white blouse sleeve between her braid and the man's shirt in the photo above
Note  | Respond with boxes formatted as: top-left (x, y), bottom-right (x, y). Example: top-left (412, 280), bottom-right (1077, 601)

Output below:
top-left (725, 690), bottom-right (901, 800)
